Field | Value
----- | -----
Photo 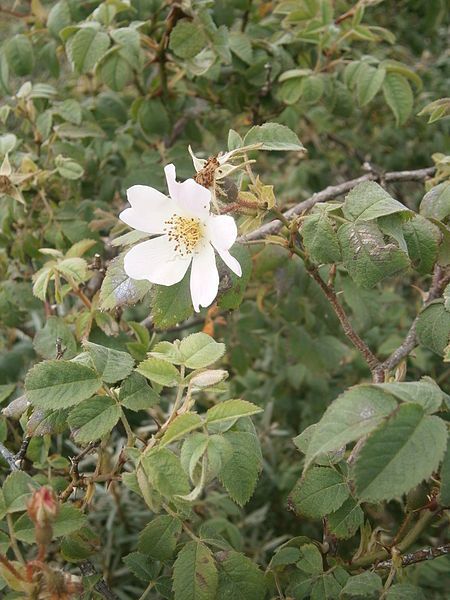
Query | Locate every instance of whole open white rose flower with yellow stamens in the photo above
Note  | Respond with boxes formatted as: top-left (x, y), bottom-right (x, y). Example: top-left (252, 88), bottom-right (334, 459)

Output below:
top-left (119, 165), bottom-right (242, 312)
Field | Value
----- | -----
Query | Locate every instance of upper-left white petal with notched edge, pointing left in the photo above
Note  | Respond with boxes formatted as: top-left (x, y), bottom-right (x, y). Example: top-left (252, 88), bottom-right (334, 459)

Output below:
top-left (119, 185), bottom-right (177, 233)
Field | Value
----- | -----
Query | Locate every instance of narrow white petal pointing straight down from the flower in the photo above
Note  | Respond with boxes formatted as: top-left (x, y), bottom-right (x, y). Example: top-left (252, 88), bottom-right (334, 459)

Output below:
top-left (191, 244), bottom-right (219, 312)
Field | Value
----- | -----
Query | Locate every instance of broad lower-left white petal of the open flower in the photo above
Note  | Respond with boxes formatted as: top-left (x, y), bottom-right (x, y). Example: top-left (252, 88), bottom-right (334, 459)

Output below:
top-left (124, 235), bottom-right (192, 285)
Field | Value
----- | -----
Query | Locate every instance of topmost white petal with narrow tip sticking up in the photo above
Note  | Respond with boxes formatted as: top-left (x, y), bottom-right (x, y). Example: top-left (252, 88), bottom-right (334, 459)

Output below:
top-left (164, 165), bottom-right (211, 218)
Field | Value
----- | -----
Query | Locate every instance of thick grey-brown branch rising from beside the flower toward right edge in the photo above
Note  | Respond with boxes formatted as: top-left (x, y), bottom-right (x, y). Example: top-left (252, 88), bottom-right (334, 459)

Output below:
top-left (243, 167), bottom-right (435, 242)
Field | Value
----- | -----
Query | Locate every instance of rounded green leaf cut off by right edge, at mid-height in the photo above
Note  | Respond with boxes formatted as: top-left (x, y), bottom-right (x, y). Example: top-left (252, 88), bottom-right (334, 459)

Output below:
top-left (416, 300), bottom-right (450, 356)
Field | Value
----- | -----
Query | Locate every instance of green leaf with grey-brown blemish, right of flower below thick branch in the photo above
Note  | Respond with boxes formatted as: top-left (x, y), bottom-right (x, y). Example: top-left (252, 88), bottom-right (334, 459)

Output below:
top-left (338, 222), bottom-right (409, 288)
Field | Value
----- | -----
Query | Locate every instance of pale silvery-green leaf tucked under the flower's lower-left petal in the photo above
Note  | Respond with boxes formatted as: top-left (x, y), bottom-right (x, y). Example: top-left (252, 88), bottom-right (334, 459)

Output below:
top-left (100, 254), bottom-right (150, 310)
